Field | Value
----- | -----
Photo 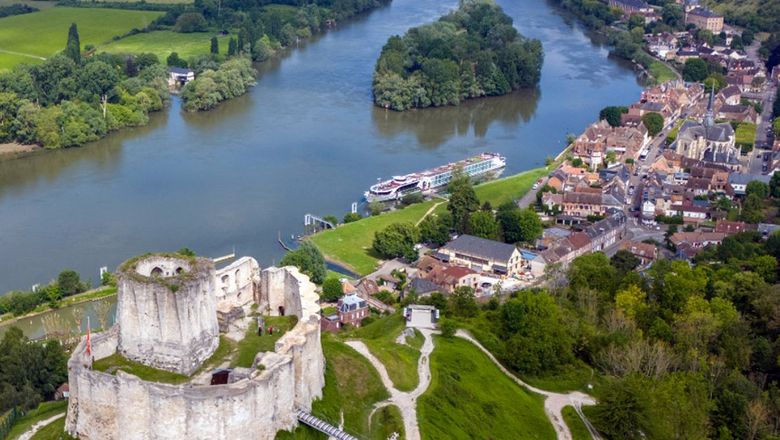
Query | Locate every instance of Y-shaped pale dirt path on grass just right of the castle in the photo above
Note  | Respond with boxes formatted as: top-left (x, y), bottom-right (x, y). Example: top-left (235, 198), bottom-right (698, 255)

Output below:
top-left (346, 329), bottom-right (433, 440)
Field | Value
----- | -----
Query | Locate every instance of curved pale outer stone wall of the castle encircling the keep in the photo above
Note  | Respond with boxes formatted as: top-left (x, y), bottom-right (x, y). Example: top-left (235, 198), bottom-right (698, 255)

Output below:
top-left (65, 268), bottom-right (325, 440)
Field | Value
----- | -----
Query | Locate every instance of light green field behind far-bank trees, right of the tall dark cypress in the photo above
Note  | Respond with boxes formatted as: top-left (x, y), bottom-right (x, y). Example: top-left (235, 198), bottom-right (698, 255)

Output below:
top-left (98, 31), bottom-right (230, 62)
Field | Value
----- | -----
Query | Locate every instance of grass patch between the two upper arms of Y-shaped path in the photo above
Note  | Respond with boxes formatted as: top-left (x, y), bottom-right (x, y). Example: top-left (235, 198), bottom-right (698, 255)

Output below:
top-left (344, 313), bottom-right (423, 391)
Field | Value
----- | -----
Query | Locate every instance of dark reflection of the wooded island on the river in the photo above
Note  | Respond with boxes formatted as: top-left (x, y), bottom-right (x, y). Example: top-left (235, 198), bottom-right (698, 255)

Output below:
top-left (371, 89), bottom-right (541, 148)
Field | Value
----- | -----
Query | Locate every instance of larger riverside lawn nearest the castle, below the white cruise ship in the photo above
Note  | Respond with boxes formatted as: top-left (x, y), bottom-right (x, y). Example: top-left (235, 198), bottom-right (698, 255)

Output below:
top-left (309, 202), bottom-right (435, 275)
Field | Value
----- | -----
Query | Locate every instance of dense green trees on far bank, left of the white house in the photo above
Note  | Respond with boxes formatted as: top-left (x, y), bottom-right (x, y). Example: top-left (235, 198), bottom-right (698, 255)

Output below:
top-left (0, 24), bottom-right (168, 148)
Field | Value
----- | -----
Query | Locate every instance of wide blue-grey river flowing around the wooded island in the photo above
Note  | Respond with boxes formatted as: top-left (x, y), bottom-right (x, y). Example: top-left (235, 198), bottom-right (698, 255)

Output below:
top-left (0, 0), bottom-right (640, 292)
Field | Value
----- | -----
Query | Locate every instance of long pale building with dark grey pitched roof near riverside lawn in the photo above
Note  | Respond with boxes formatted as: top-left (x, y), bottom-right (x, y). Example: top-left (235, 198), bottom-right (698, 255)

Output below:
top-left (439, 234), bottom-right (521, 276)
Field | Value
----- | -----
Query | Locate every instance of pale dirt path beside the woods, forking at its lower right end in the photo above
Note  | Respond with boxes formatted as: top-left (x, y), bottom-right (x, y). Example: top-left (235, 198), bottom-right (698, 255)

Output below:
top-left (456, 330), bottom-right (596, 440)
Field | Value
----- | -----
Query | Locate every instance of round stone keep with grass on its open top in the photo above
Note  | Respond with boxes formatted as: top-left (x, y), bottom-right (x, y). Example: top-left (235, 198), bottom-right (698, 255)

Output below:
top-left (117, 255), bottom-right (219, 375)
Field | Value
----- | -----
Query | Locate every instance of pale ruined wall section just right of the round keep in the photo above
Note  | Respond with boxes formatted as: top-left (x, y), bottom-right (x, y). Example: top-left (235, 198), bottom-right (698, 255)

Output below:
top-left (215, 257), bottom-right (260, 308)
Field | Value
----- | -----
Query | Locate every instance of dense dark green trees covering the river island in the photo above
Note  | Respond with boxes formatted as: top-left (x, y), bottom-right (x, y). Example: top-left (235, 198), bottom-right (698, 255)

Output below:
top-left (373, 0), bottom-right (543, 111)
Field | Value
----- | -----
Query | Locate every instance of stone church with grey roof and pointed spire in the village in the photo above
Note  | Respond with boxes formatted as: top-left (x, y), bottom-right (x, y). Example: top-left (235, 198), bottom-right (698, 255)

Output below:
top-left (674, 85), bottom-right (740, 171)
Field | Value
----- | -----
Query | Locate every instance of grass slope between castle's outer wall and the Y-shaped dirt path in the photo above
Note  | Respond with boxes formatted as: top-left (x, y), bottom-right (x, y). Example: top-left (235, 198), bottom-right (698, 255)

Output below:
top-left (276, 333), bottom-right (394, 439)
